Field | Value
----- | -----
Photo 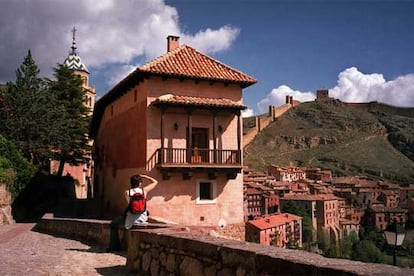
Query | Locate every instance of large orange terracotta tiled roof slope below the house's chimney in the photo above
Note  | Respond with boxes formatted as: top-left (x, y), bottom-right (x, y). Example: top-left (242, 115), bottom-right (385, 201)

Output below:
top-left (137, 45), bottom-right (257, 87)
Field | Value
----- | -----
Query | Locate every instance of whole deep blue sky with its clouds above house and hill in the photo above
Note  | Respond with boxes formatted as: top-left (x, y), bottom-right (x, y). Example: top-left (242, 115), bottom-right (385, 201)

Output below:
top-left (0, 0), bottom-right (414, 116)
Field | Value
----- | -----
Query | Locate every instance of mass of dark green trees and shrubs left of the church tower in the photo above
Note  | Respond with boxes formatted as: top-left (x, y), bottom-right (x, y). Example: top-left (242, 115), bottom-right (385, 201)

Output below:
top-left (0, 50), bottom-right (90, 198)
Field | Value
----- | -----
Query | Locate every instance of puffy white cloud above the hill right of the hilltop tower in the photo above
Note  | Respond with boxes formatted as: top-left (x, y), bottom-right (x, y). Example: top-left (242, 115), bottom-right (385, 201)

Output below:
top-left (329, 67), bottom-right (414, 107)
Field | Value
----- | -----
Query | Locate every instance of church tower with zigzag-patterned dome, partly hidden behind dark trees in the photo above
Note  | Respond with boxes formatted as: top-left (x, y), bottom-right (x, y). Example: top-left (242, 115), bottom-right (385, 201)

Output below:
top-left (50, 27), bottom-right (96, 198)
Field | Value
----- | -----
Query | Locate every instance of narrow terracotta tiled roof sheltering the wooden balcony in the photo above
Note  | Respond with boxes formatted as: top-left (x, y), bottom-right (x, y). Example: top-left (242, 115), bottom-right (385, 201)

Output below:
top-left (153, 94), bottom-right (246, 109)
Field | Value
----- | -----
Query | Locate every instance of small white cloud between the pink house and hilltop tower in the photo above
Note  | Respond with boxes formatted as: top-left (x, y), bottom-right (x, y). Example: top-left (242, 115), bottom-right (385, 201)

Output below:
top-left (257, 85), bottom-right (315, 114)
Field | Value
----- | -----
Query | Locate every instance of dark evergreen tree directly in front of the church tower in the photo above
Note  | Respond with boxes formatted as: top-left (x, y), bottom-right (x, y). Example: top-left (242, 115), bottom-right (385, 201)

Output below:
top-left (50, 64), bottom-right (90, 176)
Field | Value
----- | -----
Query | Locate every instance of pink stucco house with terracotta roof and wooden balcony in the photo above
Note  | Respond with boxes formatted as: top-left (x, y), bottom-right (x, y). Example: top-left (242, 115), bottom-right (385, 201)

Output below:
top-left (91, 36), bottom-right (256, 227)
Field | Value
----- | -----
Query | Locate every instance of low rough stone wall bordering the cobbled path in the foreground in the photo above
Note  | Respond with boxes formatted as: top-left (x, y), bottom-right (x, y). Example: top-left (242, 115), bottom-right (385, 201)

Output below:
top-left (36, 215), bottom-right (414, 276)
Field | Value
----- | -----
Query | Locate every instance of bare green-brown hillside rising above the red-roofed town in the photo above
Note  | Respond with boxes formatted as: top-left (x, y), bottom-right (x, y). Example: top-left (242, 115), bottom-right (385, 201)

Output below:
top-left (244, 100), bottom-right (414, 184)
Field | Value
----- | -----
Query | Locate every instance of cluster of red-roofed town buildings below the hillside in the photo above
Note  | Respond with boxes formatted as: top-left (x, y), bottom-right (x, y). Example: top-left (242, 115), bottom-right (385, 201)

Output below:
top-left (244, 165), bottom-right (414, 249)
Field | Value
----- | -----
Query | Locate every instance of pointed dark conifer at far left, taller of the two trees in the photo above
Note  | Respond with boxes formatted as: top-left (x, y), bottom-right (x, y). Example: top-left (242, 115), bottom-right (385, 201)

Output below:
top-left (0, 50), bottom-right (62, 166)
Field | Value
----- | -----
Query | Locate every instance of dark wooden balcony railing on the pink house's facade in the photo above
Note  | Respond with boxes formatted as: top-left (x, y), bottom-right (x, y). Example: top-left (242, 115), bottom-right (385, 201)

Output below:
top-left (157, 148), bottom-right (241, 167)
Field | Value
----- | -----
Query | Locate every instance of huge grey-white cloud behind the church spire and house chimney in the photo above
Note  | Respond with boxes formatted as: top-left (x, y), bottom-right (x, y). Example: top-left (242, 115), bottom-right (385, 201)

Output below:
top-left (0, 0), bottom-right (239, 82)
